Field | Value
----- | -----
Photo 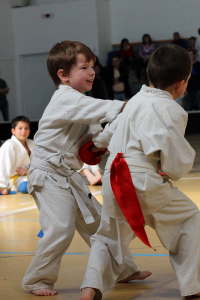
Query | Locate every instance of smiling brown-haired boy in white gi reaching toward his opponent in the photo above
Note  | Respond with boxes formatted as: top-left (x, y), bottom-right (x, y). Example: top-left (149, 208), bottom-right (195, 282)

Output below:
top-left (22, 41), bottom-right (151, 296)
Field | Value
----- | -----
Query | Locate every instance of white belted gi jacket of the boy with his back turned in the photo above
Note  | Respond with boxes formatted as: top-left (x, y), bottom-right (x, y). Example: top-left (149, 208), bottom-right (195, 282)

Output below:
top-left (93, 85), bottom-right (195, 219)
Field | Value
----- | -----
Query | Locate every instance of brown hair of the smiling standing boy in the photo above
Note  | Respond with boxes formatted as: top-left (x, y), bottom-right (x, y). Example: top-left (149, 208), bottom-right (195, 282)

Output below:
top-left (47, 41), bottom-right (96, 86)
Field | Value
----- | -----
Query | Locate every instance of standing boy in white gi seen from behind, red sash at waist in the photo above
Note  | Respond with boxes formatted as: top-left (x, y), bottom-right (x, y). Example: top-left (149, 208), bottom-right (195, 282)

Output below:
top-left (80, 44), bottom-right (200, 300)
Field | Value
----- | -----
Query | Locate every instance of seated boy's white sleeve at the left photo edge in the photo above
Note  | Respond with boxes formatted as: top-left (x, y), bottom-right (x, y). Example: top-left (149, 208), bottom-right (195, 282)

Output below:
top-left (0, 141), bottom-right (15, 188)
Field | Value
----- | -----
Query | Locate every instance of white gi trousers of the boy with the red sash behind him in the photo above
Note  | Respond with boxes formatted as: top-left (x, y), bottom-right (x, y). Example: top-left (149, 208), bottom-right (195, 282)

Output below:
top-left (81, 189), bottom-right (200, 300)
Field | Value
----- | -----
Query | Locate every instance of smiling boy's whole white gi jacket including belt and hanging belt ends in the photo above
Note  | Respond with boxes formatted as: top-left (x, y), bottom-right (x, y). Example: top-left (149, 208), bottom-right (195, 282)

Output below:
top-left (28, 85), bottom-right (124, 224)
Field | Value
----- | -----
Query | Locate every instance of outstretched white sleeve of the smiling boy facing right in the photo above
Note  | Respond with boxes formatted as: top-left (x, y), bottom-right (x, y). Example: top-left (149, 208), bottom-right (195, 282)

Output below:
top-left (66, 95), bottom-right (125, 124)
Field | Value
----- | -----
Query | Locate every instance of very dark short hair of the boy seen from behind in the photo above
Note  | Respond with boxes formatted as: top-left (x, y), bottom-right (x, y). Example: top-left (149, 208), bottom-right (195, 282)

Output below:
top-left (147, 44), bottom-right (192, 90)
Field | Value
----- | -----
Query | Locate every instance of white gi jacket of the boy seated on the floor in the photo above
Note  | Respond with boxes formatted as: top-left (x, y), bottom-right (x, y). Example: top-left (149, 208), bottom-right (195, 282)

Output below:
top-left (0, 135), bottom-right (34, 192)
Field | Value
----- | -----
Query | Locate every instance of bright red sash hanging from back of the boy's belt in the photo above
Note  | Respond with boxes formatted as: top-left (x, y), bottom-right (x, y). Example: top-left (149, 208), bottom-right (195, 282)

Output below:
top-left (110, 153), bottom-right (155, 250)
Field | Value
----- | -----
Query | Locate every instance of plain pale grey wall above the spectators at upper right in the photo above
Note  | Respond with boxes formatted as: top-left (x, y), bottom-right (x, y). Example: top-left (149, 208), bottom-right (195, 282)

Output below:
top-left (110, 0), bottom-right (200, 44)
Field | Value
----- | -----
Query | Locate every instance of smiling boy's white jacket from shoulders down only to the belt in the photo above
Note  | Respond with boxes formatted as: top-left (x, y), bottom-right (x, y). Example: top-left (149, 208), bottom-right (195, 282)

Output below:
top-left (34, 85), bottom-right (124, 170)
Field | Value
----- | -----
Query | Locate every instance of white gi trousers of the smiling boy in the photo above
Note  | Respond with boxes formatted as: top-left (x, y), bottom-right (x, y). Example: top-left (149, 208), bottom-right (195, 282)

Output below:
top-left (22, 173), bottom-right (138, 290)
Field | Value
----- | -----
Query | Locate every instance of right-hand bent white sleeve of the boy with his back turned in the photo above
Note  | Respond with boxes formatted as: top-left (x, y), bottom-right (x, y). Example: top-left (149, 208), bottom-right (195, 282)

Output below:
top-left (138, 104), bottom-right (195, 180)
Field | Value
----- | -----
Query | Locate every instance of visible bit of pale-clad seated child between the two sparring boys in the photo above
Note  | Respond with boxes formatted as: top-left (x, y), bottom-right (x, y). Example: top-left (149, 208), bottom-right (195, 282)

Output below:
top-left (80, 164), bottom-right (102, 185)
